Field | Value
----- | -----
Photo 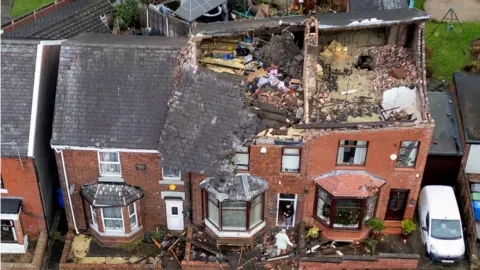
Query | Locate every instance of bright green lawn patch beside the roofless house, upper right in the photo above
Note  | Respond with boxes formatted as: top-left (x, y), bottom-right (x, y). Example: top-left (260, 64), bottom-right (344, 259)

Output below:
top-left (425, 22), bottom-right (480, 80)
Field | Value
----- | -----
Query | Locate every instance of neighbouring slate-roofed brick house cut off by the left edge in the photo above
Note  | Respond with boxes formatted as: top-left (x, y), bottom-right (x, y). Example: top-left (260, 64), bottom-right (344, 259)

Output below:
top-left (0, 38), bottom-right (60, 253)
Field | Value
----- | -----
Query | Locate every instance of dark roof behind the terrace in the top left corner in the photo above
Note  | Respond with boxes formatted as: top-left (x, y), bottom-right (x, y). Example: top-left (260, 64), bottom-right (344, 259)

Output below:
top-left (2, 0), bottom-right (113, 40)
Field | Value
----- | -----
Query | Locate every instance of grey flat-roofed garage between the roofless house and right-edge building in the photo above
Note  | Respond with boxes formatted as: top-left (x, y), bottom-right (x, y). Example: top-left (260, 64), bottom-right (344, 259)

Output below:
top-left (422, 92), bottom-right (463, 187)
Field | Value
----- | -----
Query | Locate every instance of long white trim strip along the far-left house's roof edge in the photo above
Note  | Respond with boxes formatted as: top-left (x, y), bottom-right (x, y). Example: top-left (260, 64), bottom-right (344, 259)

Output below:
top-left (27, 43), bottom-right (43, 157)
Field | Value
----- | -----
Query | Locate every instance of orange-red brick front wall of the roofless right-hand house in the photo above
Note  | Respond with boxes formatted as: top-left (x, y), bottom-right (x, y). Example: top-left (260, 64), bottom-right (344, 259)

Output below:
top-left (304, 125), bottom-right (432, 237)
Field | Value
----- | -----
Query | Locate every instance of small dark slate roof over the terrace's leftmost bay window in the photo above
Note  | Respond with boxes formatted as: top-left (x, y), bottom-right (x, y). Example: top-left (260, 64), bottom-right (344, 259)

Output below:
top-left (81, 182), bottom-right (144, 207)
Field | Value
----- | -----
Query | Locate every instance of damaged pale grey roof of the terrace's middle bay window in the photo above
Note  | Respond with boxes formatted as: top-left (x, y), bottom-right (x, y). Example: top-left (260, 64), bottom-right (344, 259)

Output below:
top-left (200, 174), bottom-right (268, 202)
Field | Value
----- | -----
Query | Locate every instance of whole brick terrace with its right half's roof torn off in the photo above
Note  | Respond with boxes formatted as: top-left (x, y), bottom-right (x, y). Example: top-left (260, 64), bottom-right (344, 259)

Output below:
top-left (52, 9), bottom-right (433, 243)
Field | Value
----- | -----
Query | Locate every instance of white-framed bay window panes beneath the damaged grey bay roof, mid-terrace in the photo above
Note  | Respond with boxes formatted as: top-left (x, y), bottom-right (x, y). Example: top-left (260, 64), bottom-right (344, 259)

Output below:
top-left (206, 192), bottom-right (264, 231)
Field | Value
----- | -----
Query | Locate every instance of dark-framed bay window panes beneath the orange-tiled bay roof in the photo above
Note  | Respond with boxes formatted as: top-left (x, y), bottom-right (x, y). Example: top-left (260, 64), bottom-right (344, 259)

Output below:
top-left (315, 185), bottom-right (377, 230)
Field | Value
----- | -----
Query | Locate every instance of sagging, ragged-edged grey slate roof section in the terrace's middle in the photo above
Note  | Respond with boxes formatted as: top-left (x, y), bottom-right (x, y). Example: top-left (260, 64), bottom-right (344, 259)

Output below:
top-left (159, 66), bottom-right (258, 176)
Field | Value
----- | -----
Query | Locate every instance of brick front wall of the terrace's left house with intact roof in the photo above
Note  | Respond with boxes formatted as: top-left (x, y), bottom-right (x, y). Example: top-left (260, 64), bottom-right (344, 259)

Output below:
top-left (56, 150), bottom-right (189, 234)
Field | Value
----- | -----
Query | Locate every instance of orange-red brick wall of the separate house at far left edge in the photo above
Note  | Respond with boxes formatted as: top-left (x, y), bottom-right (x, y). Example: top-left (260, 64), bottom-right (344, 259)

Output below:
top-left (0, 158), bottom-right (46, 237)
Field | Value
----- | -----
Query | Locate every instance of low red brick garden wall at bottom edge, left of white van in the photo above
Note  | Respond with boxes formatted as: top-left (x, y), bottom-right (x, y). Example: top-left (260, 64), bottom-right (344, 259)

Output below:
top-left (299, 253), bottom-right (420, 270)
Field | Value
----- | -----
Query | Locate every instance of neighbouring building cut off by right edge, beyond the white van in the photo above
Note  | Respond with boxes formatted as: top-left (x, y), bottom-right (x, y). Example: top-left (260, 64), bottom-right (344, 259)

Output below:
top-left (453, 72), bottom-right (480, 267)
